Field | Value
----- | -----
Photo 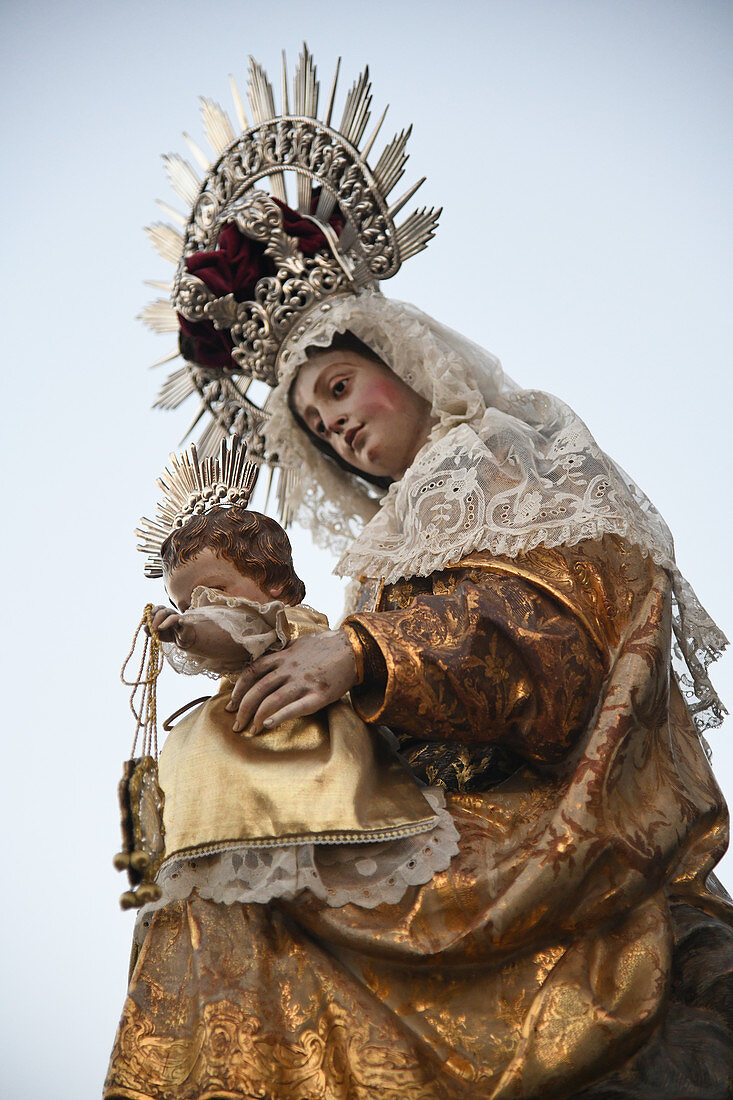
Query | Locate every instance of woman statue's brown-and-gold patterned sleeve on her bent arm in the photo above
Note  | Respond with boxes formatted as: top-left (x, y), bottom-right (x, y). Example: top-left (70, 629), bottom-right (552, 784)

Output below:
top-left (344, 541), bottom-right (616, 762)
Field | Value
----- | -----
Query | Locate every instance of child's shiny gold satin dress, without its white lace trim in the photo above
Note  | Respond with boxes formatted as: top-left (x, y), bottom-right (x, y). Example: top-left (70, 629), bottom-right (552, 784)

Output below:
top-left (158, 606), bottom-right (435, 858)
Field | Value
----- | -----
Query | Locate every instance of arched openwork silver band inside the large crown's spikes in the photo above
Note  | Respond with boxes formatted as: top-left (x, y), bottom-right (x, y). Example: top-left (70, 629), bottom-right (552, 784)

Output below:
top-left (184, 116), bottom-right (400, 279)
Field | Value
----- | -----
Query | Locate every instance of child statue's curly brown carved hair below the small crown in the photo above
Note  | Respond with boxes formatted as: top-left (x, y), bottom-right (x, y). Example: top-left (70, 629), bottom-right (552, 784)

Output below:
top-left (161, 506), bottom-right (305, 604)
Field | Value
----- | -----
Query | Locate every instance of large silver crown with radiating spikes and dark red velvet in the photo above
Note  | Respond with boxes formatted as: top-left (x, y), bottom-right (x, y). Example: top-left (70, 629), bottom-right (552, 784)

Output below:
top-left (142, 46), bottom-right (440, 461)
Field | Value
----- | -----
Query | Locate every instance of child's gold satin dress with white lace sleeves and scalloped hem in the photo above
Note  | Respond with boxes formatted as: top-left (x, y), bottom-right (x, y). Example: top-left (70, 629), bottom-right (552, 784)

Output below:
top-left (135, 587), bottom-right (458, 937)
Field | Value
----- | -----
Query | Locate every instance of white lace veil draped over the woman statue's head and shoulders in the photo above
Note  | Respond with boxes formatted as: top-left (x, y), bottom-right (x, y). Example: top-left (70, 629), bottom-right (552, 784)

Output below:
top-left (267, 292), bottom-right (726, 729)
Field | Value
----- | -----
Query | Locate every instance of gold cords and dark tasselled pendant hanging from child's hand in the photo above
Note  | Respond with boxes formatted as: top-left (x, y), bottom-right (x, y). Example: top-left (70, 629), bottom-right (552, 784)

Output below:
top-left (113, 604), bottom-right (165, 909)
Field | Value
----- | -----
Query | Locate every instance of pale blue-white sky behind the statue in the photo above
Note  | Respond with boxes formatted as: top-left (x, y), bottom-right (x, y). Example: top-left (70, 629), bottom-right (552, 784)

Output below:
top-left (0, 0), bottom-right (733, 1100)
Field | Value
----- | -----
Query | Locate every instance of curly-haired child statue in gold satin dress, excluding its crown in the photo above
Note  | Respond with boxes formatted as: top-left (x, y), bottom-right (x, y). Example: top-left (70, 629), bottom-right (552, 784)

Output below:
top-left (136, 505), bottom-right (457, 923)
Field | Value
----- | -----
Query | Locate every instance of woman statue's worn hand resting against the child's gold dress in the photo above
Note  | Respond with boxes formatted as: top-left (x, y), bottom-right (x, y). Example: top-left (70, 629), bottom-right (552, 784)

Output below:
top-left (227, 630), bottom-right (357, 736)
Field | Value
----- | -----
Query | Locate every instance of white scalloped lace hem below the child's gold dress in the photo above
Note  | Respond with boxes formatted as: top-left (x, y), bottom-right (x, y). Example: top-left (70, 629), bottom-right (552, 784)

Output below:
top-left (135, 788), bottom-right (459, 941)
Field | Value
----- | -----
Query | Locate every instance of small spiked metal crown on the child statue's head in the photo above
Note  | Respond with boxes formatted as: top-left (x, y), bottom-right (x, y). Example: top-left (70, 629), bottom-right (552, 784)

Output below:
top-left (135, 437), bottom-right (258, 578)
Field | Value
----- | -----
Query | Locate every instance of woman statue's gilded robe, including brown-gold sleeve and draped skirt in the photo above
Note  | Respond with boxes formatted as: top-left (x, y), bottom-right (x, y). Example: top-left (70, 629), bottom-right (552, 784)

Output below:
top-left (105, 539), bottom-right (733, 1100)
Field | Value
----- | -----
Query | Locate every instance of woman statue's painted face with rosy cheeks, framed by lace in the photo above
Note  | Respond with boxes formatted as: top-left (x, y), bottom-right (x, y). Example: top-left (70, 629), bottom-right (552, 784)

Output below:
top-left (292, 350), bottom-right (435, 481)
